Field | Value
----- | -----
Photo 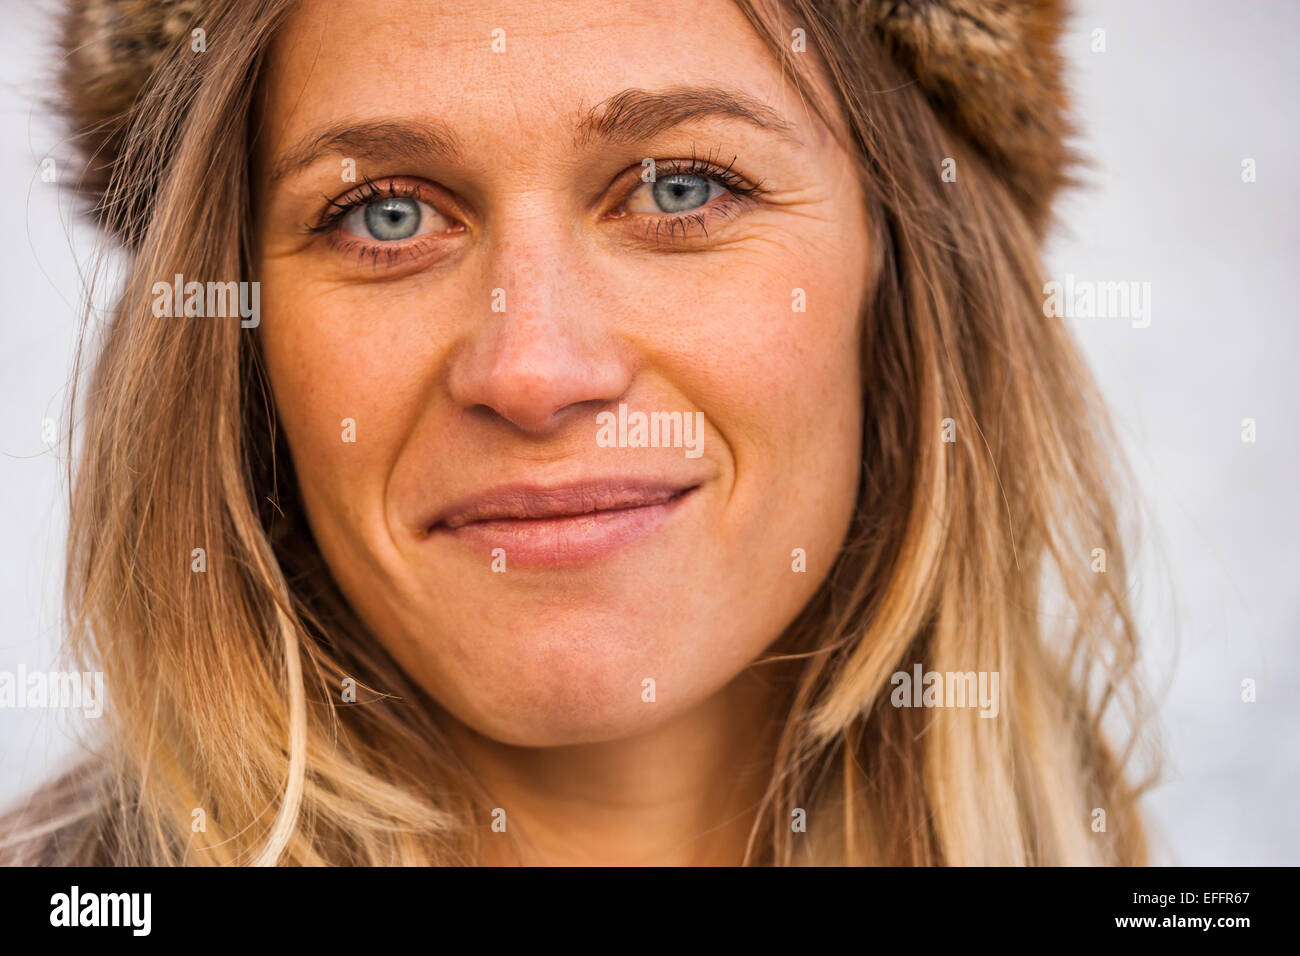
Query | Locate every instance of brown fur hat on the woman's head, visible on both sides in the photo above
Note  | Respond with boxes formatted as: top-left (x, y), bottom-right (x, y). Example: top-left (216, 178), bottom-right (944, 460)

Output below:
top-left (60, 0), bottom-right (1073, 232)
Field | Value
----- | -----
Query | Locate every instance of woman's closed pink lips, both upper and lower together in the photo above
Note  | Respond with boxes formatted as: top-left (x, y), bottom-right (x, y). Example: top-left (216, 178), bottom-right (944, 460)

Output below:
top-left (424, 479), bottom-right (701, 570)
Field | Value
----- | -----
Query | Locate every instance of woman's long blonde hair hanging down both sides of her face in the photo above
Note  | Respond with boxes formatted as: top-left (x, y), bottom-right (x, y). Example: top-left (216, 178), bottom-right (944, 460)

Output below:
top-left (4, 0), bottom-right (1147, 865)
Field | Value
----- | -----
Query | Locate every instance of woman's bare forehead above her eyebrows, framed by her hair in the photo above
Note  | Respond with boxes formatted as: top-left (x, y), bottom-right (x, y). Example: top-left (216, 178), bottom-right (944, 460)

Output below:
top-left (265, 0), bottom-right (828, 155)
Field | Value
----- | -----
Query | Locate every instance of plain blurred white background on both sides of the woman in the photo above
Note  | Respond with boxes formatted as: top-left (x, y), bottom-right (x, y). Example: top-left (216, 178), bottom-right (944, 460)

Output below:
top-left (0, 0), bottom-right (1300, 865)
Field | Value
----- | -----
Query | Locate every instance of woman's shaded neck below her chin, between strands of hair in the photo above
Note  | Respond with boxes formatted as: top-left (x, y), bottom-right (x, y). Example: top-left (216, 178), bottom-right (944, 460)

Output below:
top-left (442, 670), bottom-right (780, 866)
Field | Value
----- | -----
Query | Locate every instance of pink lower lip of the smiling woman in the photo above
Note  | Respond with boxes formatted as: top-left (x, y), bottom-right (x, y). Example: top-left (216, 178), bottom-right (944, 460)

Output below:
top-left (430, 488), bottom-right (697, 570)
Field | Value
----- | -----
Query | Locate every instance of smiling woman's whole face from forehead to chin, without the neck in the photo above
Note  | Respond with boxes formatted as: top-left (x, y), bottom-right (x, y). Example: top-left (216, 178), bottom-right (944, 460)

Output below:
top-left (255, 0), bottom-right (868, 745)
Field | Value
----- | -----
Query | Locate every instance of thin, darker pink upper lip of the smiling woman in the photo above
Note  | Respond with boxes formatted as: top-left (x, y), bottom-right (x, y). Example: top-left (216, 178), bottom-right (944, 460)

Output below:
top-left (424, 479), bottom-right (699, 532)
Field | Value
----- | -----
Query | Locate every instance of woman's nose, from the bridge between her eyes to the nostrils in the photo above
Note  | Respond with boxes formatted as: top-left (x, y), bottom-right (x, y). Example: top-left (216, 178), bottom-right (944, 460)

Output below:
top-left (449, 217), bottom-right (632, 434)
